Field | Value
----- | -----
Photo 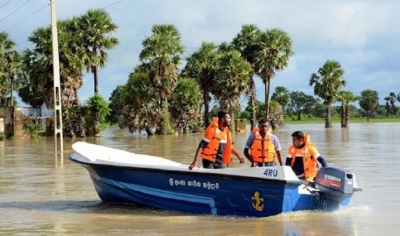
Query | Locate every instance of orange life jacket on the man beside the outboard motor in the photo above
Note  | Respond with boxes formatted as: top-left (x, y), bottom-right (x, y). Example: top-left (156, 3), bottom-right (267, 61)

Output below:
top-left (290, 134), bottom-right (318, 181)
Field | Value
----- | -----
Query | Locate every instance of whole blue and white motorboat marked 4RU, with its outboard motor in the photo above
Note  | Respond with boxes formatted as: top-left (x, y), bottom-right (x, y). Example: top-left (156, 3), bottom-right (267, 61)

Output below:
top-left (69, 142), bottom-right (360, 217)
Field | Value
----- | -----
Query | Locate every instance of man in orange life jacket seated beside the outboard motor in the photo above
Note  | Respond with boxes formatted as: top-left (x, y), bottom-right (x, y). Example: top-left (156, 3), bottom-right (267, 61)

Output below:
top-left (285, 131), bottom-right (328, 181)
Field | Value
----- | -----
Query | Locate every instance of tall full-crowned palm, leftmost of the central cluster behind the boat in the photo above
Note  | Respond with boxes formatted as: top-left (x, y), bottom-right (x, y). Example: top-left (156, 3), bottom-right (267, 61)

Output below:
top-left (139, 24), bottom-right (184, 134)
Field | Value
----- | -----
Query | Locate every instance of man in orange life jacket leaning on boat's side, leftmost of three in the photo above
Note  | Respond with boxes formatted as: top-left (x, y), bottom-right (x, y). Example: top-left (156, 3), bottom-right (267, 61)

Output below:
top-left (189, 111), bottom-right (243, 170)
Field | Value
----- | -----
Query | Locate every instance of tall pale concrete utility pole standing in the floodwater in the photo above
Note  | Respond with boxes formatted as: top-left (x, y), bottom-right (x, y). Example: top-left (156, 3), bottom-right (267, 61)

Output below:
top-left (50, 0), bottom-right (64, 153)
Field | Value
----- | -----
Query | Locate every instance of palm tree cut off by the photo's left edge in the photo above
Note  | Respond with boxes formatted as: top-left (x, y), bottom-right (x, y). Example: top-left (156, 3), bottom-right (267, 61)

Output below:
top-left (0, 32), bottom-right (21, 106)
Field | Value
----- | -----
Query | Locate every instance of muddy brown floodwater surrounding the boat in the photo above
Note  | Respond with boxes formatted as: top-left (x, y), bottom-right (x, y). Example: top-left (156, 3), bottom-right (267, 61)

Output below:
top-left (0, 123), bottom-right (400, 236)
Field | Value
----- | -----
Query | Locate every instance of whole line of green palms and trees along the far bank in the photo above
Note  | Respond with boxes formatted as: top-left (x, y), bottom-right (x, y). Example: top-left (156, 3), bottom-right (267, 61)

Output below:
top-left (0, 9), bottom-right (400, 136)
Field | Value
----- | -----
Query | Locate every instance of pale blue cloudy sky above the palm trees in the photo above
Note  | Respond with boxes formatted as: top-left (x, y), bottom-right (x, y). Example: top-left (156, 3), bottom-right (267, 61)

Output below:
top-left (0, 0), bottom-right (400, 107)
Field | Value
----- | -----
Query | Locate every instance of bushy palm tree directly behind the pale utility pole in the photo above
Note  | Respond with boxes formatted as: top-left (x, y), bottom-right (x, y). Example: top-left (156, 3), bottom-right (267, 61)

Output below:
top-left (23, 20), bottom-right (84, 136)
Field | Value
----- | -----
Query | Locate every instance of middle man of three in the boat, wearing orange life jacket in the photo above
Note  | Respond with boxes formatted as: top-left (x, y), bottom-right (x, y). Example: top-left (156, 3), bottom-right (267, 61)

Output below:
top-left (243, 119), bottom-right (282, 167)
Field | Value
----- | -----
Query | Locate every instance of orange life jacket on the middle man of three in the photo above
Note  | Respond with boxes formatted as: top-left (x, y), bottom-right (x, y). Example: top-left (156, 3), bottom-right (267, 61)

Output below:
top-left (250, 129), bottom-right (275, 163)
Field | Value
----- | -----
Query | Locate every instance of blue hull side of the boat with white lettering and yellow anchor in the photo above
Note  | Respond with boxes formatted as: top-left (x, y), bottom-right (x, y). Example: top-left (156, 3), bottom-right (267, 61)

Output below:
top-left (77, 159), bottom-right (315, 217)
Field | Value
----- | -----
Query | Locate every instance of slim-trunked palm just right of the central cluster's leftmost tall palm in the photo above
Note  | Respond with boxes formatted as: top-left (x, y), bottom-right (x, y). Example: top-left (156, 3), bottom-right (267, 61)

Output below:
top-left (182, 42), bottom-right (218, 127)
